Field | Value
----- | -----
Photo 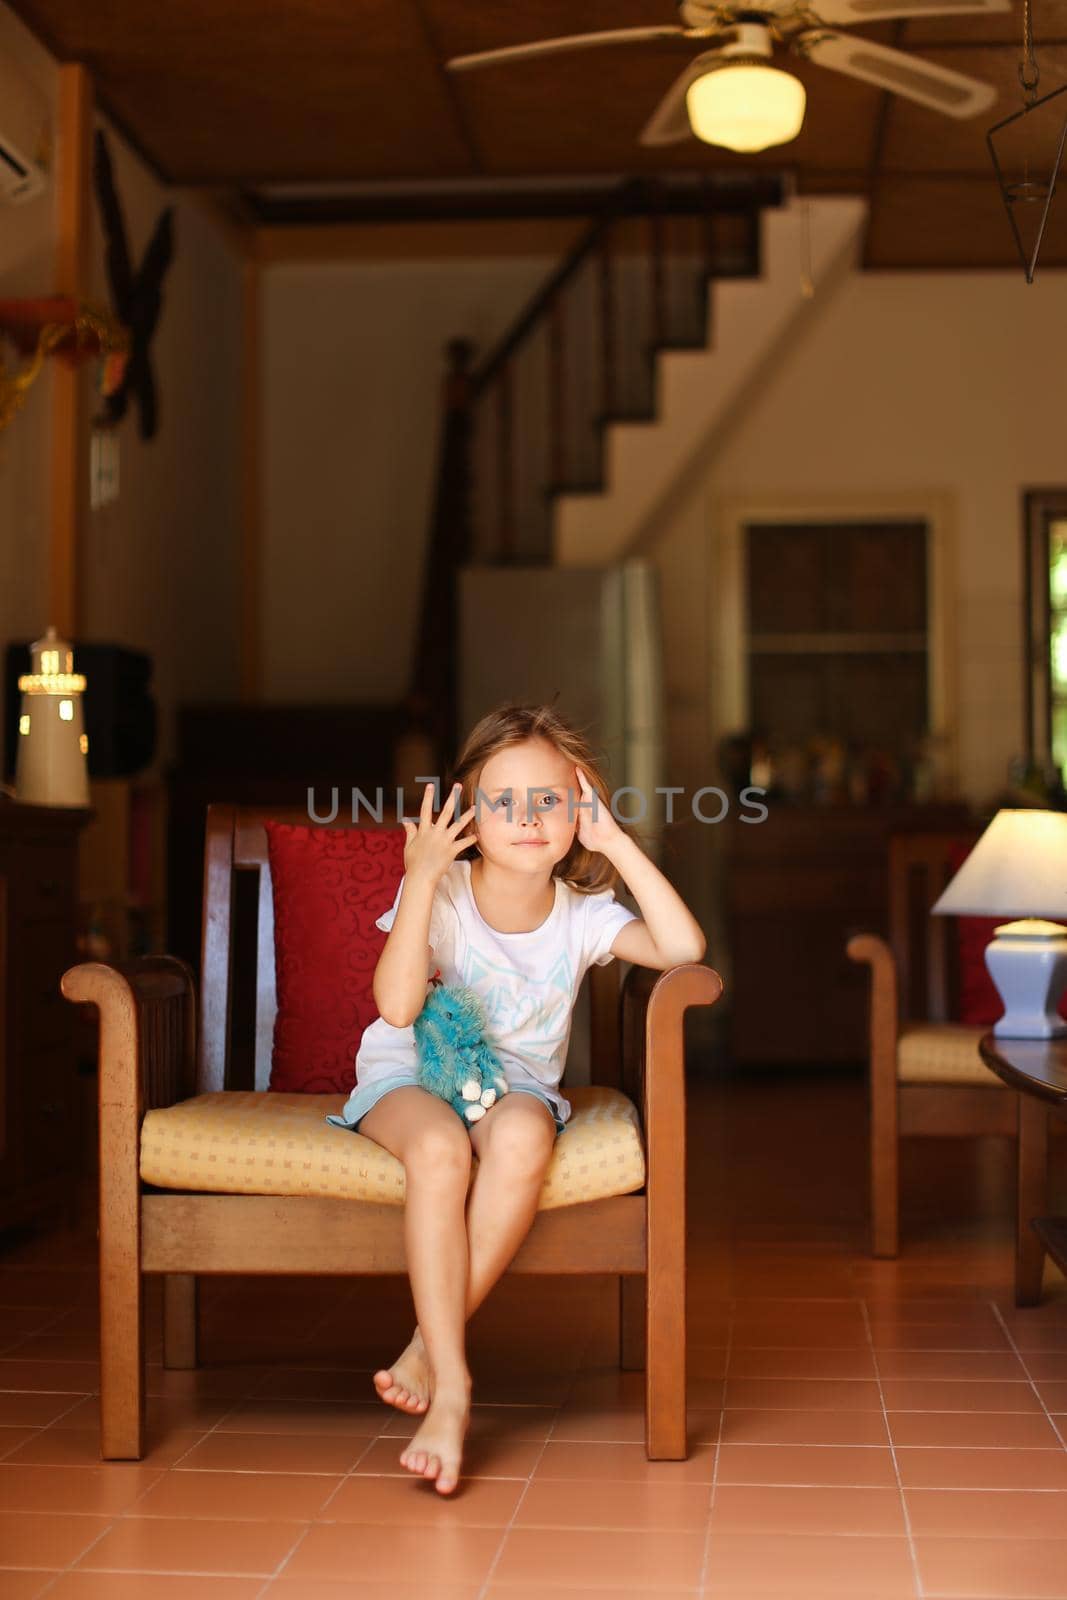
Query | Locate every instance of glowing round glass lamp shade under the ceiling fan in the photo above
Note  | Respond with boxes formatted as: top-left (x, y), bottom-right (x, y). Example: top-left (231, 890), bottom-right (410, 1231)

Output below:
top-left (685, 61), bottom-right (806, 150)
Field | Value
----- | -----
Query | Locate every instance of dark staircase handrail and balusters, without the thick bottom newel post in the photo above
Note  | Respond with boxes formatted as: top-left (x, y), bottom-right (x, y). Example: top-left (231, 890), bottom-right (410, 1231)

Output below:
top-left (467, 179), bottom-right (781, 565)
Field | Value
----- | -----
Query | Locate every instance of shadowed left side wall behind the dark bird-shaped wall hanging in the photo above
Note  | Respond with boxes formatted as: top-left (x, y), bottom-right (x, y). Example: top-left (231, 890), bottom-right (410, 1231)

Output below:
top-left (0, 0), bottom-right (242, 765)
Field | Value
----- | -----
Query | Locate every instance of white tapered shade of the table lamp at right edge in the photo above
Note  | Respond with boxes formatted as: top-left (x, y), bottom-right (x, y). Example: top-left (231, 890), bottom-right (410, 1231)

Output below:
top-left (931, 810), bottom-right (1067, 922)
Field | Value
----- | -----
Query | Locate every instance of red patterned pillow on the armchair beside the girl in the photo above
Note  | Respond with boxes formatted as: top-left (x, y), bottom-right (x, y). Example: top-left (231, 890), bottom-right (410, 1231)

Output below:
top-left (266, 822), bottom-right (405, 1094)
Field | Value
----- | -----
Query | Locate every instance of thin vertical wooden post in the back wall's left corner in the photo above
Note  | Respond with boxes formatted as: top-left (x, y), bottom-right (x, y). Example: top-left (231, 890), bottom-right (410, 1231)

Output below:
top-left (240, 258), bottom-right (262, 701)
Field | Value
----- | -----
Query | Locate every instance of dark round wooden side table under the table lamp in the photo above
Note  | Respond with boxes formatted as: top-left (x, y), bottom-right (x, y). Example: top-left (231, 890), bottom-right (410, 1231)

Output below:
top-left (977, 1032), bottom-right (1067, 1306)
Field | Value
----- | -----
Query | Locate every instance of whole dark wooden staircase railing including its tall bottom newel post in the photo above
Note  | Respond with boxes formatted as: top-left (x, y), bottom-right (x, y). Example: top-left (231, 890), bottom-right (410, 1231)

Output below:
top-left (408, 173), bottom-right (782, 750)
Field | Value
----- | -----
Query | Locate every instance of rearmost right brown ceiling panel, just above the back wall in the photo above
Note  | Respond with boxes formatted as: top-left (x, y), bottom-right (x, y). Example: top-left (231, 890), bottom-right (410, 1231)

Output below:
top-left (864, 170), bottom-right (1067, 264)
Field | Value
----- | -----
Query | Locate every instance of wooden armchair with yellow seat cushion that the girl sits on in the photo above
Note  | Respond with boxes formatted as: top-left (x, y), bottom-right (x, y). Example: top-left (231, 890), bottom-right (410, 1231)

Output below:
top-left (62, 805), bottom-right (723, 1461)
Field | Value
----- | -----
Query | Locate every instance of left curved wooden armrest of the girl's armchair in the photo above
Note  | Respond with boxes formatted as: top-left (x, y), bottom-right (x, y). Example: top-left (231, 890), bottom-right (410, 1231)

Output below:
top-left (59, 955), bottom-right (197, 1120)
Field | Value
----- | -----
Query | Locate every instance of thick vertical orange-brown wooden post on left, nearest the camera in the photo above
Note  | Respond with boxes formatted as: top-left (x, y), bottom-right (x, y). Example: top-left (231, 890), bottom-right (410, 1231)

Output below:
top-left (48, 62), bottom-right (93, 638)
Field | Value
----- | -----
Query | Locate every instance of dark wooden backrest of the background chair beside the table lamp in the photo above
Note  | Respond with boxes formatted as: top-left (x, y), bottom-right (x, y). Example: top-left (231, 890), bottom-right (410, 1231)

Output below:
top-left (889, 827), bottom-right (982, 1022)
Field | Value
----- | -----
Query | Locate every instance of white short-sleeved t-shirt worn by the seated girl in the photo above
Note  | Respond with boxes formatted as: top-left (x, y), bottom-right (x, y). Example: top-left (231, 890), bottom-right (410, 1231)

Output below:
top-left (337, 858), bottom-right (637, 1122)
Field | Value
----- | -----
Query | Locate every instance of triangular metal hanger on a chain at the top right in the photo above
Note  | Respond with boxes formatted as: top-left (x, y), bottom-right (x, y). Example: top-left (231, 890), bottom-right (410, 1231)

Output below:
top-left (985, 0), bottom-right (1067, 283)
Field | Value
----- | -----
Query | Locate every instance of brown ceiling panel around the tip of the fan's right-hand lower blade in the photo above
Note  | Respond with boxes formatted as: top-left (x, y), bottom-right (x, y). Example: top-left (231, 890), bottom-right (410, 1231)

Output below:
top-left (881, 46), bottom-right (1067, 173)
